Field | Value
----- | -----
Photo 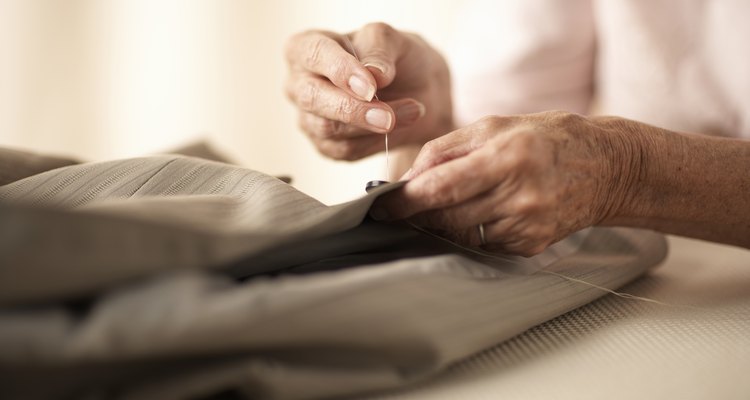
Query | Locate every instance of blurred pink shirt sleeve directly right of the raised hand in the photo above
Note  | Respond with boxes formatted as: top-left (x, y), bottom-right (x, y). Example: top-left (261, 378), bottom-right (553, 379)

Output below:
top-left (449, 0), bottom-right (596, 126)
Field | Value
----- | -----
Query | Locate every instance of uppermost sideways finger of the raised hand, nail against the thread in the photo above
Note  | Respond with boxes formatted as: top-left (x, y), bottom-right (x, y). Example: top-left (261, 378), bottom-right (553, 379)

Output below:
top-left (286, 31), bottom-right (377, 101)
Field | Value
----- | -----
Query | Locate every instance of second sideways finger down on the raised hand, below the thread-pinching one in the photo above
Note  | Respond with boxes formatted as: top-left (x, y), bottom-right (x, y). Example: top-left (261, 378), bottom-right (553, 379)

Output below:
top-left (286, 73), bottom-right (395, 133)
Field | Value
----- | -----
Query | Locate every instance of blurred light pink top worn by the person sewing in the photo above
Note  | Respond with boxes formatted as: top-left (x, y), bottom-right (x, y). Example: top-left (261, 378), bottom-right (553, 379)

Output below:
top-left (449, 0), bottom-right (750, 138)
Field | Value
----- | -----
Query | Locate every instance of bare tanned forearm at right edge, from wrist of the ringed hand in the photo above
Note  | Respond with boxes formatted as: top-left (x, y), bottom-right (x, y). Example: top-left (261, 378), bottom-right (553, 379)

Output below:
top-left (602, 115), bottom-right (750, 248)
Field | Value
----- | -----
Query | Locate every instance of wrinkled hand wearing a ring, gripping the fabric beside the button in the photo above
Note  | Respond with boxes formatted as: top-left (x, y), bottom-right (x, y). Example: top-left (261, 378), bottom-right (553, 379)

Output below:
top-left (371, 112), bottom-right (637, 256)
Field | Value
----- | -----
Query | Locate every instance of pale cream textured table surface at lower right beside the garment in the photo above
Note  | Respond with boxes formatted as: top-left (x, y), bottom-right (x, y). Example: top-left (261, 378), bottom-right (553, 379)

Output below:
top-left (373, 237), bottom-right (750, 400)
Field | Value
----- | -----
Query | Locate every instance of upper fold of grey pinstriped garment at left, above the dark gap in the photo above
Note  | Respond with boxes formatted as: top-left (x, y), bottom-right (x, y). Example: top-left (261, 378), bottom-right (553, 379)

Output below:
top-left (0, 156), bottom-right (362, 303)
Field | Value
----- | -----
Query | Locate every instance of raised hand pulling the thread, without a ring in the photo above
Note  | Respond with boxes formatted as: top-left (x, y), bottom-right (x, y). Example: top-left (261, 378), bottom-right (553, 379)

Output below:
top-left (286, 23), bottom-right (453, 160)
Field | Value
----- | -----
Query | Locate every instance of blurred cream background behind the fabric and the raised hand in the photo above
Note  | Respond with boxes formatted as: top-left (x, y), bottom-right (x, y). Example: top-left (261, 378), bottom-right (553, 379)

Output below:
top-left (0, 0), bottom-right (459, 204)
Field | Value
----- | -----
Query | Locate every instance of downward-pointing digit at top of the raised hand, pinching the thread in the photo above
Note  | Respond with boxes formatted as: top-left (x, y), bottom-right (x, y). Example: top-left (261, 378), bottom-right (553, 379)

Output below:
top-left (352, 22), bottom-right (404, 88)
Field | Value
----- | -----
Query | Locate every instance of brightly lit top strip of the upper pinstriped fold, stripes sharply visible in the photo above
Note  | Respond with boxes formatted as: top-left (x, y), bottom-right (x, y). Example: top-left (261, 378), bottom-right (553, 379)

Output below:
top-left (0, 156), bottom-right (324, 225)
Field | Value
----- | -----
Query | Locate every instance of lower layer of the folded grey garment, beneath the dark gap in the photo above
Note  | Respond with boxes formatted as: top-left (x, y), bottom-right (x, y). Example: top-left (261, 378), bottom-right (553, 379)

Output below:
top-left (0, 230), bottom-right (659, 399)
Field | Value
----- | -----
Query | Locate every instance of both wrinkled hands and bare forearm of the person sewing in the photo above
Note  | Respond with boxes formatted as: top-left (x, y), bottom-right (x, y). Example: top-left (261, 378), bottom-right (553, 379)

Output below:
top-left (286, 23), bottom-right (750, 256)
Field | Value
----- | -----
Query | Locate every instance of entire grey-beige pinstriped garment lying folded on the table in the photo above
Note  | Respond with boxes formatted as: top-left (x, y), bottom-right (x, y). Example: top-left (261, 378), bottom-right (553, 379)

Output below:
top-left (0, 156), bottom-right (666, 399)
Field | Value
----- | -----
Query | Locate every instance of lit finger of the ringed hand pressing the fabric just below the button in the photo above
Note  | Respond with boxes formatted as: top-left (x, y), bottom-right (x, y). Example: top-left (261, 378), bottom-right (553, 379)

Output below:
top-left (373, 146), bottom-right (506, 220)
